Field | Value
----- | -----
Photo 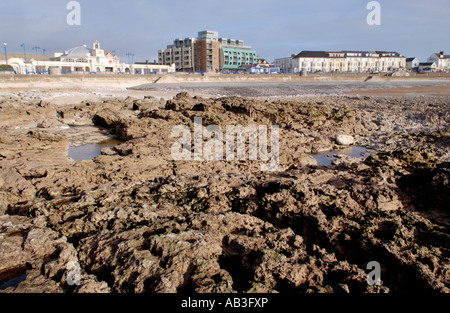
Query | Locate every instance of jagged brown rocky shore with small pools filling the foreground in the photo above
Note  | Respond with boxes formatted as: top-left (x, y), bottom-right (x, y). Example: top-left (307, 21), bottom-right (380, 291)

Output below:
top-left (0, 88), bottom-right (450, 293)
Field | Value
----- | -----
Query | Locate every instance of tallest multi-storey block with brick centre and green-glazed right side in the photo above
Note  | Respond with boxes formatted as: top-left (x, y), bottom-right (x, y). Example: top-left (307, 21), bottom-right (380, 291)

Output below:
top-left (158, 30), bottom-right (258, 72)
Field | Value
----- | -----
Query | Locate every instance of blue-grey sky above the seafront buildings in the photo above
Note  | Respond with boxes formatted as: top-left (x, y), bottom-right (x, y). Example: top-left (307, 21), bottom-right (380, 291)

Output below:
top-left (0, 0), bottom-right (450, 62)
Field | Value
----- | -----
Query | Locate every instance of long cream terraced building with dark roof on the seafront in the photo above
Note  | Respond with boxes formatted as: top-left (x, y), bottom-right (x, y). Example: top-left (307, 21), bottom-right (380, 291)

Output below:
top-left (274, 51), bottom-right (406, 73)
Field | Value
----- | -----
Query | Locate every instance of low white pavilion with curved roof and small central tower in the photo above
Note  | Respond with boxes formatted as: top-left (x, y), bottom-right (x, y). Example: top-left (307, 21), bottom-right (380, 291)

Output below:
top-left (0, 41), bottom-right (175, 75)
